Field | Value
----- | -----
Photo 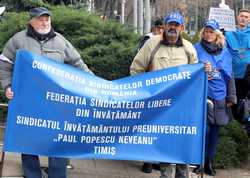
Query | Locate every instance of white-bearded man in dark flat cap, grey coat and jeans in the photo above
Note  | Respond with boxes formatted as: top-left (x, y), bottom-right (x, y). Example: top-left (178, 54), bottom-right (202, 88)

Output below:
top-left (0, 7), bottom-right (92, 178)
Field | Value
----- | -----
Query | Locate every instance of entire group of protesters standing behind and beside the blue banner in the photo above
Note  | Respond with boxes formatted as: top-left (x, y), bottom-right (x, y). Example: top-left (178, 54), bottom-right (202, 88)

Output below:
top-left (0, 7), bottom-right (250, 178)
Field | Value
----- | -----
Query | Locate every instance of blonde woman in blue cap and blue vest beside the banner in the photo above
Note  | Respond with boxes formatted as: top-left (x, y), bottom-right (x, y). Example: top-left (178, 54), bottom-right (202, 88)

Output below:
top-left (194, 20), bottom-right (236, 176)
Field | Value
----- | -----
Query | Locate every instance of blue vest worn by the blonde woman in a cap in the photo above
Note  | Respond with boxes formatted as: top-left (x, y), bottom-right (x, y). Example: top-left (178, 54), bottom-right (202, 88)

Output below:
top-left (195, 43), bottom-right (232, 100)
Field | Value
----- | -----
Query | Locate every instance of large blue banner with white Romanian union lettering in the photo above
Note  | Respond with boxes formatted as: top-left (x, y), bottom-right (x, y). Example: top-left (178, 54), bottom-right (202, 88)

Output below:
top-left (4, 51), bottom-right (207, 164)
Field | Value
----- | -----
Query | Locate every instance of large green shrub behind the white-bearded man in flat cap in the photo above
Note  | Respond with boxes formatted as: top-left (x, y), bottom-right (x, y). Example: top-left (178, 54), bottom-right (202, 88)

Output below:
top-left (0, 6), bottom-right (139, 80)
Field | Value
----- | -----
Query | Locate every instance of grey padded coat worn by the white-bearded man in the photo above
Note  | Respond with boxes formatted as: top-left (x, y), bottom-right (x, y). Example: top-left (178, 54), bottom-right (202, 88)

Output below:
top-left (0, 30), bottom-right (92, 89)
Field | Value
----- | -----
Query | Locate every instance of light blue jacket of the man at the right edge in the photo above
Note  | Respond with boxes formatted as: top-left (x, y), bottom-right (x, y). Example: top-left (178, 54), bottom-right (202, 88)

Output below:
top-left (225, 26), bottom-right (250, 79)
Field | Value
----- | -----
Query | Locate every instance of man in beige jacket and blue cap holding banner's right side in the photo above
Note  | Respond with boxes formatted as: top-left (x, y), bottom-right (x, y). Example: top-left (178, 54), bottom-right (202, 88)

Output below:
top-left (130, 11), bottom-right (200, 178)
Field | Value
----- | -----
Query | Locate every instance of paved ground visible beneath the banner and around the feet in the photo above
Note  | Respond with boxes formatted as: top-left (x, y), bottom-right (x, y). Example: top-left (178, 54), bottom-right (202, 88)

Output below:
top-left (0, 153), bottom-right (250, 178)
